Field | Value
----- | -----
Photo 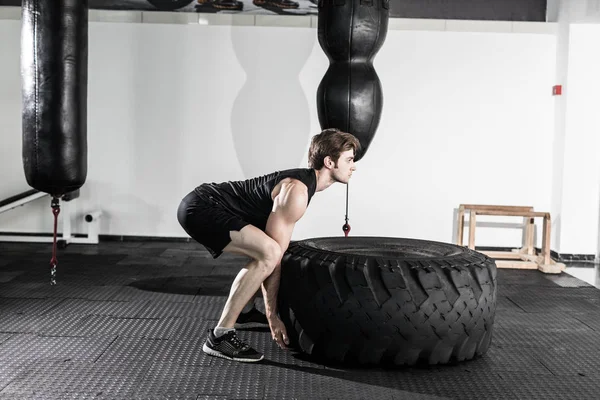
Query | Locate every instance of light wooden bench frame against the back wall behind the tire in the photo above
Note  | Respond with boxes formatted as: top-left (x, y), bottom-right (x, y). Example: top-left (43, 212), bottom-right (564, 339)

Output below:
top-left (456, 204), bottom-right (565, 274)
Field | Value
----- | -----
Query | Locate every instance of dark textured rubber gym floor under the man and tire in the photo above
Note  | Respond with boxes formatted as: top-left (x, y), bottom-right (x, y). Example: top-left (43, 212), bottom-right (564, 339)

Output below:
top-left (0, 241), bottom-right (600, 399)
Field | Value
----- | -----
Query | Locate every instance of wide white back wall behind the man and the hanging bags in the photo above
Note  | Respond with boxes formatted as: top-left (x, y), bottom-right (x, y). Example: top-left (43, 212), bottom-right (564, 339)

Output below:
top-left (0, 21), bottom-right (560, 253)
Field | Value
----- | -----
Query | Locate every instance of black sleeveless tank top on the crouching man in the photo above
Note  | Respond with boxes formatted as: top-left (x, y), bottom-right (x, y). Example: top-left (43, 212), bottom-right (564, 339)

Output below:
top-left (194, 168), bottom-right (317, 231)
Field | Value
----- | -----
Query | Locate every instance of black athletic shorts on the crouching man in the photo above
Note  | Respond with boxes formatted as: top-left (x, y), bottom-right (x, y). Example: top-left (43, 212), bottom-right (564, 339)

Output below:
top-left (177, 191), bottom-right (250, 258)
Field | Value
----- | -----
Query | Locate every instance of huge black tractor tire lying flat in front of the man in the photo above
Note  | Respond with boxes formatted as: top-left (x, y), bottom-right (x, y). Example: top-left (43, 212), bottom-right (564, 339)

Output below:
top-left (278, 237), bottom-right (497, 365)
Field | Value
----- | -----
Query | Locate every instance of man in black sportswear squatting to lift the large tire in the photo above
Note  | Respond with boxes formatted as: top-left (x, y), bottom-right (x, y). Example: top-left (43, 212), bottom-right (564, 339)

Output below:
top-left (177, 129), bottom-right (360, 362)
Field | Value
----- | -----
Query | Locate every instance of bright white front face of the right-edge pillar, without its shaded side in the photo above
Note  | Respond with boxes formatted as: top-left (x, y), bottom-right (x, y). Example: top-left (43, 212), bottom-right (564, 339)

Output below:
top-left (560, 24), bottom-right (600, 254)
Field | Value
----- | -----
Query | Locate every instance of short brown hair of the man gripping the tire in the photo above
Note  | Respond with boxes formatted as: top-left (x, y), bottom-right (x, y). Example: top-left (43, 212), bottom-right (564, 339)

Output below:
top-left (308, 128), bottom-right (360, 169)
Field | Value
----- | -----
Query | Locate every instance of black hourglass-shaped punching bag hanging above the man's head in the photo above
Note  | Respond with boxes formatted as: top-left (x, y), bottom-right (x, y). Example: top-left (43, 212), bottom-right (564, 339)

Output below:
top-left (317, 0), bottom-right (389, 160)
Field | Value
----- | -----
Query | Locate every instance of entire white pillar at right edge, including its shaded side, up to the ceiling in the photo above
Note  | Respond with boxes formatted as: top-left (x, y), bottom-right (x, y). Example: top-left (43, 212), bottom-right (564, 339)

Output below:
top-left (548, 0), bottom-right (600, 254)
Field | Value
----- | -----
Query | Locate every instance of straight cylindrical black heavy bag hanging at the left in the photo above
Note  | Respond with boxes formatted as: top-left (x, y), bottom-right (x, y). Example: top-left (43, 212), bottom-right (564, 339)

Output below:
top-left (21, 0), bottom-right (88, 197)
